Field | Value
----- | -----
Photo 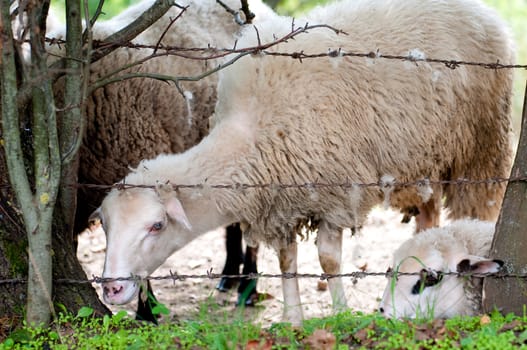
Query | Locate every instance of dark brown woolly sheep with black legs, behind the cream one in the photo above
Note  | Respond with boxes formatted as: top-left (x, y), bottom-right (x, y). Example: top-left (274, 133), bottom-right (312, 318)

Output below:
top-left (48, 0), bottom-right (274, 312)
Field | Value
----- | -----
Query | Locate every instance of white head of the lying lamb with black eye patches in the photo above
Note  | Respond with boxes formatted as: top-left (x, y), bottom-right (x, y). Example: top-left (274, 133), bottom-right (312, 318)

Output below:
top-left (379, 235), bottom-right (503, 318)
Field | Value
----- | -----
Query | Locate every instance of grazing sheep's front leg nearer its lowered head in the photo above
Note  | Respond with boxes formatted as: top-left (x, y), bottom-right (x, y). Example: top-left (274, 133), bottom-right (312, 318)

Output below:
top-left (278, 242), bottom-right (304, 327)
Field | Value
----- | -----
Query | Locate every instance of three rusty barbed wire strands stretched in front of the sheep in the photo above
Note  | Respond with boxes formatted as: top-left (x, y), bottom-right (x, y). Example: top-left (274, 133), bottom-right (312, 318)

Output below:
top-left (6, 1), bottom-right (527, 300)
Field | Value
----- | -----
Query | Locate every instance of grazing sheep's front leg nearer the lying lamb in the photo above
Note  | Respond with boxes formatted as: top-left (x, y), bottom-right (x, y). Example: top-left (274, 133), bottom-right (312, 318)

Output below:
top-left (317, 223), bottom-right (347, 312)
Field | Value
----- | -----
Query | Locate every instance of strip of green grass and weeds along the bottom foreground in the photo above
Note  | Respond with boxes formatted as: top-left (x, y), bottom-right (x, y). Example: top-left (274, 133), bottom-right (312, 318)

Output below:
top-left (0, 304), bottom-right (527, 350)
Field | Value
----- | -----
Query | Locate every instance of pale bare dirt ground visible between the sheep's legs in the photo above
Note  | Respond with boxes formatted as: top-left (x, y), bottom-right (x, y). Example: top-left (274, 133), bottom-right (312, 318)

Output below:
top-left (78, 209), bottom-right (422, 326)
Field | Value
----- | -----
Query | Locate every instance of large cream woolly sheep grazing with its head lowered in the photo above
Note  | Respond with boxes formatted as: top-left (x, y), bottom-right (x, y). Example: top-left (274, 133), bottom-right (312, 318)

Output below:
top-left (94, 0), bottom-right (514, 326)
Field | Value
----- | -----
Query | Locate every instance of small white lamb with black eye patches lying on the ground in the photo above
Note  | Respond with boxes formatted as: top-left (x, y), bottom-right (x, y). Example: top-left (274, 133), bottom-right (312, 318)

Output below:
top-left (379, 219), bottom-right (503, 318)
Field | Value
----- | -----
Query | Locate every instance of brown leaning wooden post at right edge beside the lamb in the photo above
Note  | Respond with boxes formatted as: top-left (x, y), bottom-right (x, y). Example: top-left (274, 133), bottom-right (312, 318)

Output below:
top-left (483, 82), bottom-right (527, 316)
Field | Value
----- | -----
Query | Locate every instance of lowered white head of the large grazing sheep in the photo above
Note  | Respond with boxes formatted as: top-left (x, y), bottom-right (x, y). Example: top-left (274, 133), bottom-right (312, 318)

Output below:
top-left (90, 185), bottom-right (192, 304)
